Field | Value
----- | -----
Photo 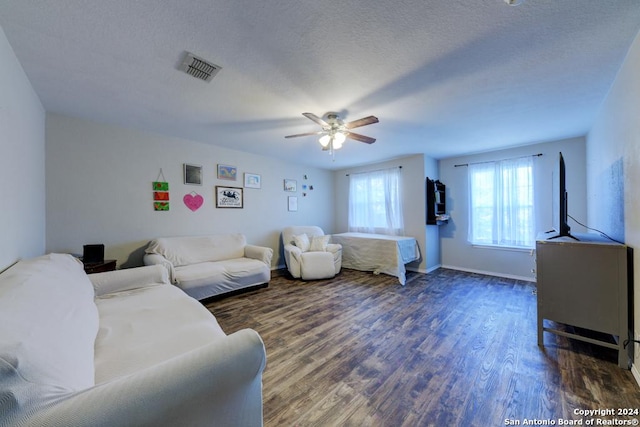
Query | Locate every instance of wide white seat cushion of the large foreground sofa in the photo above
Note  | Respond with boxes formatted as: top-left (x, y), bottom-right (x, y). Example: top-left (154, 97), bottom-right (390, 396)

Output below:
top-left (95, 284), bottom-right (226, 384)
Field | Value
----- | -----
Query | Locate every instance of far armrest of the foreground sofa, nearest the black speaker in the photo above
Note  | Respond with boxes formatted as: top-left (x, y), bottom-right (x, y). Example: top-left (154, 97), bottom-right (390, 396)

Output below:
top-left (88, 265), bottom-right (169, 296)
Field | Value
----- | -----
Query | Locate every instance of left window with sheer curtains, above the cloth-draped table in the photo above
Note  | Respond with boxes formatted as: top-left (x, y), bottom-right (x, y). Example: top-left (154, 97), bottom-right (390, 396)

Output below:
top-left (349, 168), bottom-right (404, 235)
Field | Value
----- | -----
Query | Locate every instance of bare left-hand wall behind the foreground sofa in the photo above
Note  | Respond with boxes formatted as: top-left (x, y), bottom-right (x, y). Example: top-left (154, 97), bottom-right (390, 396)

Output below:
top-left (0, 28), bottom-right (45, 271)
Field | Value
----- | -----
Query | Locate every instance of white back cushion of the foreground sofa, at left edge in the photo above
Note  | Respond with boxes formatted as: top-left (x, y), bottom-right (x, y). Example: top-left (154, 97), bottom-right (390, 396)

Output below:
top-left (0, 254), bottom-right (98, 398)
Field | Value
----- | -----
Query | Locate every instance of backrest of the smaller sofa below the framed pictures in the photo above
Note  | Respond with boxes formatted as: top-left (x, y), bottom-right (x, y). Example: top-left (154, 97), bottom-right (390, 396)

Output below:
top-left (145, 234), bottom-right (247, 267)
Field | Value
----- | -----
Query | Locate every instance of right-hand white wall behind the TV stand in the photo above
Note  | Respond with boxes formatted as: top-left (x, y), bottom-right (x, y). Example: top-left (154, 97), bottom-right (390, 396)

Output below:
top-left (587, 31), bottom-right (640, 374)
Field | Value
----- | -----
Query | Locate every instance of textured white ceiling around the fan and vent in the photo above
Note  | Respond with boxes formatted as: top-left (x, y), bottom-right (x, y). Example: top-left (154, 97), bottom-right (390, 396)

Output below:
top-left (0, 0), bottom-right (640, 169)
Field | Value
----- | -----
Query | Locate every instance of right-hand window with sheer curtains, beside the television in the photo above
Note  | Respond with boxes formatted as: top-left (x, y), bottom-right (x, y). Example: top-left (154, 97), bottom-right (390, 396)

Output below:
top-left (469, 157), bottom-right (535, 248)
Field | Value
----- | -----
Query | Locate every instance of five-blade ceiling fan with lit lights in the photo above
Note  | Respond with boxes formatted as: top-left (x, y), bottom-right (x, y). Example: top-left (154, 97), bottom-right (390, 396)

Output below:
top-left (285, 113), bottom-right (378, 154)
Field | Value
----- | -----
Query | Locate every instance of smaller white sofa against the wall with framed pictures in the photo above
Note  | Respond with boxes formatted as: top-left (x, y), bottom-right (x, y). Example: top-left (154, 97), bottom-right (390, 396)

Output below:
top-left (143, 234), bottom-right (273, 300)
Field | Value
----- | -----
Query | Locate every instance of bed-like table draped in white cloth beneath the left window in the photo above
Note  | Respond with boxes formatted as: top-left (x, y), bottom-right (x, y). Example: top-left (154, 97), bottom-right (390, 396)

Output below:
top-left (331, 233), bottom-right (420, 285)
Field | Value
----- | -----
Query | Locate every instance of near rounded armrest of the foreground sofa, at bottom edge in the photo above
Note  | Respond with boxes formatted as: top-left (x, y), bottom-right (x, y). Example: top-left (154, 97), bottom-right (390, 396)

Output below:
top-left (18, 329), bottom-right (266, 427)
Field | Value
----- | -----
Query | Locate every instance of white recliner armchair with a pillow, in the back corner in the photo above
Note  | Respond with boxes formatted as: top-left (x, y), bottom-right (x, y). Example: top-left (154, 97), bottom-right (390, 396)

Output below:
top-left (282, 225), bottom-right (342, 280)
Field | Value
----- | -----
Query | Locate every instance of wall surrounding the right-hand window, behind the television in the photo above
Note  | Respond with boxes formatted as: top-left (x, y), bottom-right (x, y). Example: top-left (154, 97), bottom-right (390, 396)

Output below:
top-left (440, 137), bottom-right (587, 281)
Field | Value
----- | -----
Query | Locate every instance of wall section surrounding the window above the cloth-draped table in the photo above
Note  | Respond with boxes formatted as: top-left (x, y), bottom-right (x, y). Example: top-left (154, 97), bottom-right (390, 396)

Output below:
top-left (334, 154), bottom-right (426, 272)
